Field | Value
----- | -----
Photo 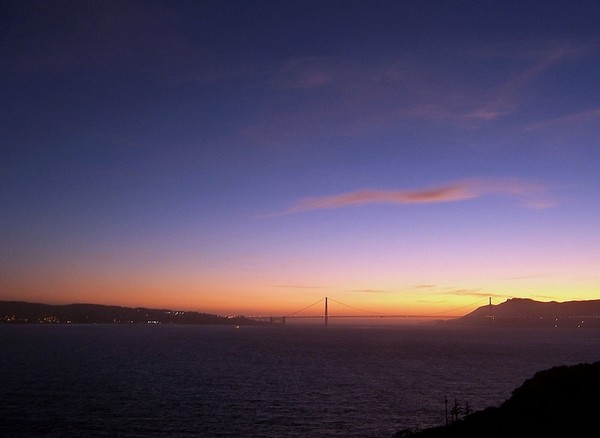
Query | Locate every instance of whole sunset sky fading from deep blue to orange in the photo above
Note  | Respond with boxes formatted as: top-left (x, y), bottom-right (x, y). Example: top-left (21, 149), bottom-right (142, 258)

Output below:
top-left (0, 0), bottom-right (600, 315)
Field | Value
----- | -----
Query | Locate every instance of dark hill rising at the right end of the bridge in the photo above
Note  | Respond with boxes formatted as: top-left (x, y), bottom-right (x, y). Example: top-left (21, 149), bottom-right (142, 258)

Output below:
top-left (446, 298), bottom-right (600, 328)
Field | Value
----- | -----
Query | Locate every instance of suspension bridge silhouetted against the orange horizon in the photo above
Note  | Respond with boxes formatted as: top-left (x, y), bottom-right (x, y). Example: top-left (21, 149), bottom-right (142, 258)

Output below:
top-left (249, 297), bottom-right (492, 326)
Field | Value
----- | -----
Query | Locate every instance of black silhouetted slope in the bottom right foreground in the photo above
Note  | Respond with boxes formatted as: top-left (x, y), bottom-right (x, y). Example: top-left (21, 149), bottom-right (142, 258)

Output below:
top-left (395, 362), bottom-right (600, 438)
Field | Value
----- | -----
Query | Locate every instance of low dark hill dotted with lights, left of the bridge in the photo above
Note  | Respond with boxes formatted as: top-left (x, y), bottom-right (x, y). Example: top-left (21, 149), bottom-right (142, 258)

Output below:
top-left (0, 301), bottom-right (260, 325)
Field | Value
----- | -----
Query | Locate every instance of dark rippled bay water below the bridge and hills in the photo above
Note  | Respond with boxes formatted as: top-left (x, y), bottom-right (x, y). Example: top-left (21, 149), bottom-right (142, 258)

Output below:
top-left (0, 325), bottom-right (600, 438)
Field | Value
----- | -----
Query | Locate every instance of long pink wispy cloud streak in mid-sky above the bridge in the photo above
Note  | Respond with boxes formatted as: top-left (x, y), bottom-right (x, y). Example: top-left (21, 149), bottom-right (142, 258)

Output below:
top-left (267, 179), bottom-right (555, 216)
